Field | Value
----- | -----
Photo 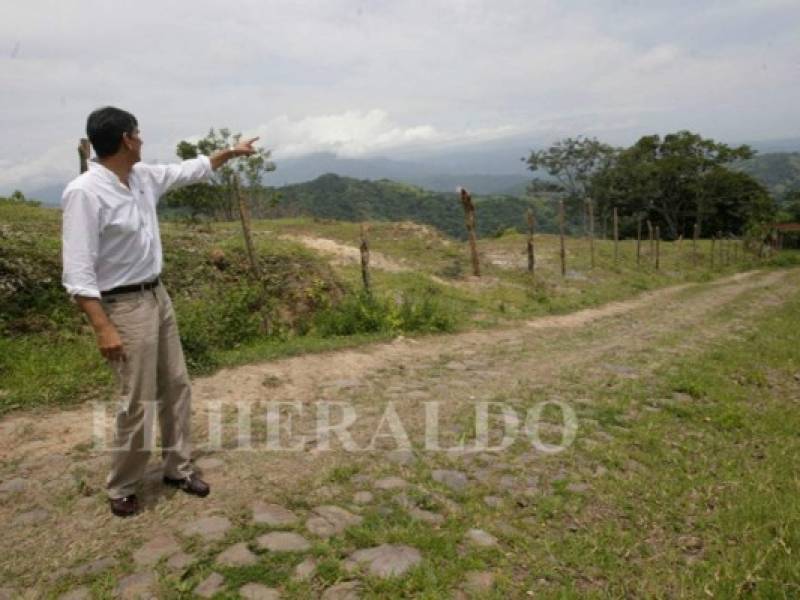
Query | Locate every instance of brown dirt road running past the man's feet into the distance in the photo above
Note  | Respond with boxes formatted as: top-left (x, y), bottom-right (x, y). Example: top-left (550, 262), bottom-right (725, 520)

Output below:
top-left (0, 270), bottom-right (800, 598)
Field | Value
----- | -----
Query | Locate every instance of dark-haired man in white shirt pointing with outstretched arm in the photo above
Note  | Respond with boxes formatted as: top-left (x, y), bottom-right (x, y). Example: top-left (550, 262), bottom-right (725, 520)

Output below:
top-left (62, 106), bottom-right (258, 517)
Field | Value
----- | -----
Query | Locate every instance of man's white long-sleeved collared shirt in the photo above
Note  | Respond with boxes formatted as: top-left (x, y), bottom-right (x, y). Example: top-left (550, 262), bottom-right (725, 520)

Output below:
top-left (61, 156), bottom-right (212, 298)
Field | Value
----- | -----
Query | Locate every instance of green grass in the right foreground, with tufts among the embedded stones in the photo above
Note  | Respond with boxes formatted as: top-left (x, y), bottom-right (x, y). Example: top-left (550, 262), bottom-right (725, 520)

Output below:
top-left (62, 270), bottom-right (800, 600)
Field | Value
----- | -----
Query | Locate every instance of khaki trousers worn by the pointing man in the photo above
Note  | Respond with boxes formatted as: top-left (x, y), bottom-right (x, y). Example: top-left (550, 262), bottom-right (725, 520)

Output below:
top-left (102, 284), bottom-right (193, 498)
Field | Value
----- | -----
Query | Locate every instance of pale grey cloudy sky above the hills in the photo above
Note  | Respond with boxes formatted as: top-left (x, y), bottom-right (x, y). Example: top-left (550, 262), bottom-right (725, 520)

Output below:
top-left (0, 0), bottom-right (800, 193)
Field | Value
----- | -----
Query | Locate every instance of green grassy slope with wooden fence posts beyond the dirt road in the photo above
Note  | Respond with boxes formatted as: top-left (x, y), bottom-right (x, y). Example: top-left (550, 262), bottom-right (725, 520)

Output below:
top-left (0, 202), bottom-right (795, 413)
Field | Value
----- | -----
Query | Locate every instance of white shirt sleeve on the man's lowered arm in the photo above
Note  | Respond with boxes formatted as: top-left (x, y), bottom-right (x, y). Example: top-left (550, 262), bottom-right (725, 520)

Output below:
top-left (61, 188), bottom-right (100, 298)
